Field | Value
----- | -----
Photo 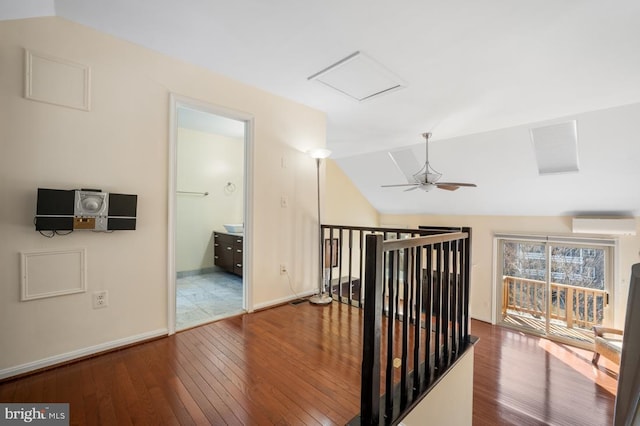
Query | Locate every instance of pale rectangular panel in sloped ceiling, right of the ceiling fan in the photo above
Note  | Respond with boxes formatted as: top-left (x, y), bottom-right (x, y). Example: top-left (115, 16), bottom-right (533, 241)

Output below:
top-left (531, 120), bottom-right (579, 175)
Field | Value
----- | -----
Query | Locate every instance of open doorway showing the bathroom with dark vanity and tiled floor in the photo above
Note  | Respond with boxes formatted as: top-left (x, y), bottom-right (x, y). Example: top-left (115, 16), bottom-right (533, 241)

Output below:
top-left (169, 96), bottom-right (251, 333)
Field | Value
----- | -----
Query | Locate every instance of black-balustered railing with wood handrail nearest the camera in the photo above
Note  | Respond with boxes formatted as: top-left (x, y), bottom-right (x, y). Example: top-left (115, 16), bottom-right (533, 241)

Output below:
top-left (338, 228), bottom-right (471, 425)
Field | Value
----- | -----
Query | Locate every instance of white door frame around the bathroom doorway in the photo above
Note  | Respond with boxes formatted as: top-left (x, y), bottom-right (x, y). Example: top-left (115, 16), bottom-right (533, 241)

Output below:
top-left (167, 93), bottom-right (254, 335)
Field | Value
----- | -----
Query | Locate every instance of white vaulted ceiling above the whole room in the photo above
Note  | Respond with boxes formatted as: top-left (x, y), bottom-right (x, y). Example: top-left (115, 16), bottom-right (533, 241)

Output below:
top-left (0, 0), bottom-right (640, 215)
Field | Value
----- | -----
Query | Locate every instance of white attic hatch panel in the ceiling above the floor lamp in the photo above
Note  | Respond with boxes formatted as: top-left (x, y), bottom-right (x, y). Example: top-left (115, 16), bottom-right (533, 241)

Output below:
top-left (308, 52), bottom-right (405, 102)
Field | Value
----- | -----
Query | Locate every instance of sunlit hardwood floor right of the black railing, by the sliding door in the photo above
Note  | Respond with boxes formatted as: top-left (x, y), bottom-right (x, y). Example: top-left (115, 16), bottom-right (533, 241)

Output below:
top-left (471, 320), bottom-right (618, 426)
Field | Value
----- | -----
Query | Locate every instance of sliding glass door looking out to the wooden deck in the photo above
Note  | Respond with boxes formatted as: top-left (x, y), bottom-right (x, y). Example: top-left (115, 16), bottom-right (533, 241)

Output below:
top-left (497, 238), bottom-right (613, 346)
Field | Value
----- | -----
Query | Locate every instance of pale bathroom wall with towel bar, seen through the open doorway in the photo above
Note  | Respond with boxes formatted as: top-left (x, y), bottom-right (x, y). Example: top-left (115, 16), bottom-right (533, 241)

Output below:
top-left (176, 128), bottom-right (244, 272)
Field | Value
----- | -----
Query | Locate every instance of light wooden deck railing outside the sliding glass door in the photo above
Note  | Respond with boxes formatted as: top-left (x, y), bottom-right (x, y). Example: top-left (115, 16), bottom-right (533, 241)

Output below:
top-left (502, 276), bottom-right (608, 329)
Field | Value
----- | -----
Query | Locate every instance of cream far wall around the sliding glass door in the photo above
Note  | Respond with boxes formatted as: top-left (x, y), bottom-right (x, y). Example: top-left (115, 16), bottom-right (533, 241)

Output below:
top-left (380, 215), bottom-right (640, 327)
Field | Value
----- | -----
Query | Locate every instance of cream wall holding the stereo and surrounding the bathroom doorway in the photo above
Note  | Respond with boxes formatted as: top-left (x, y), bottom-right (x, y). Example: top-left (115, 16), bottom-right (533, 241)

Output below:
top-left (0, 18), bottom-right (326, 377)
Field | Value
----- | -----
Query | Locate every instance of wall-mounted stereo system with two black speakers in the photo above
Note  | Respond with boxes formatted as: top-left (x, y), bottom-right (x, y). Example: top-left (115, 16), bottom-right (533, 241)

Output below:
top-left (35, 188), bottom-right (138, 231)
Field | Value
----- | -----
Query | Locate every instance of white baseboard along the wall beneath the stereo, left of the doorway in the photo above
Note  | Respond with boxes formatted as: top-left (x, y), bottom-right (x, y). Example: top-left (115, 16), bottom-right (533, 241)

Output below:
top-left (0, 328), bottom-right (168, 379)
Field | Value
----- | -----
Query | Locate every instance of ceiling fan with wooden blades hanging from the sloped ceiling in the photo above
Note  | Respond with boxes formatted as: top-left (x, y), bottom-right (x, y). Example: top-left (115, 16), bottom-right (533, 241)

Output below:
top-left (382, 133), bottom-right (476, 192)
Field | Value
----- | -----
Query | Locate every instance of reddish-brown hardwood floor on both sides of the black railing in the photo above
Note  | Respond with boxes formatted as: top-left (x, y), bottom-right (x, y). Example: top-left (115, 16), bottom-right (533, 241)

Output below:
top-left (0, 303), bottom-right (615, 425)
